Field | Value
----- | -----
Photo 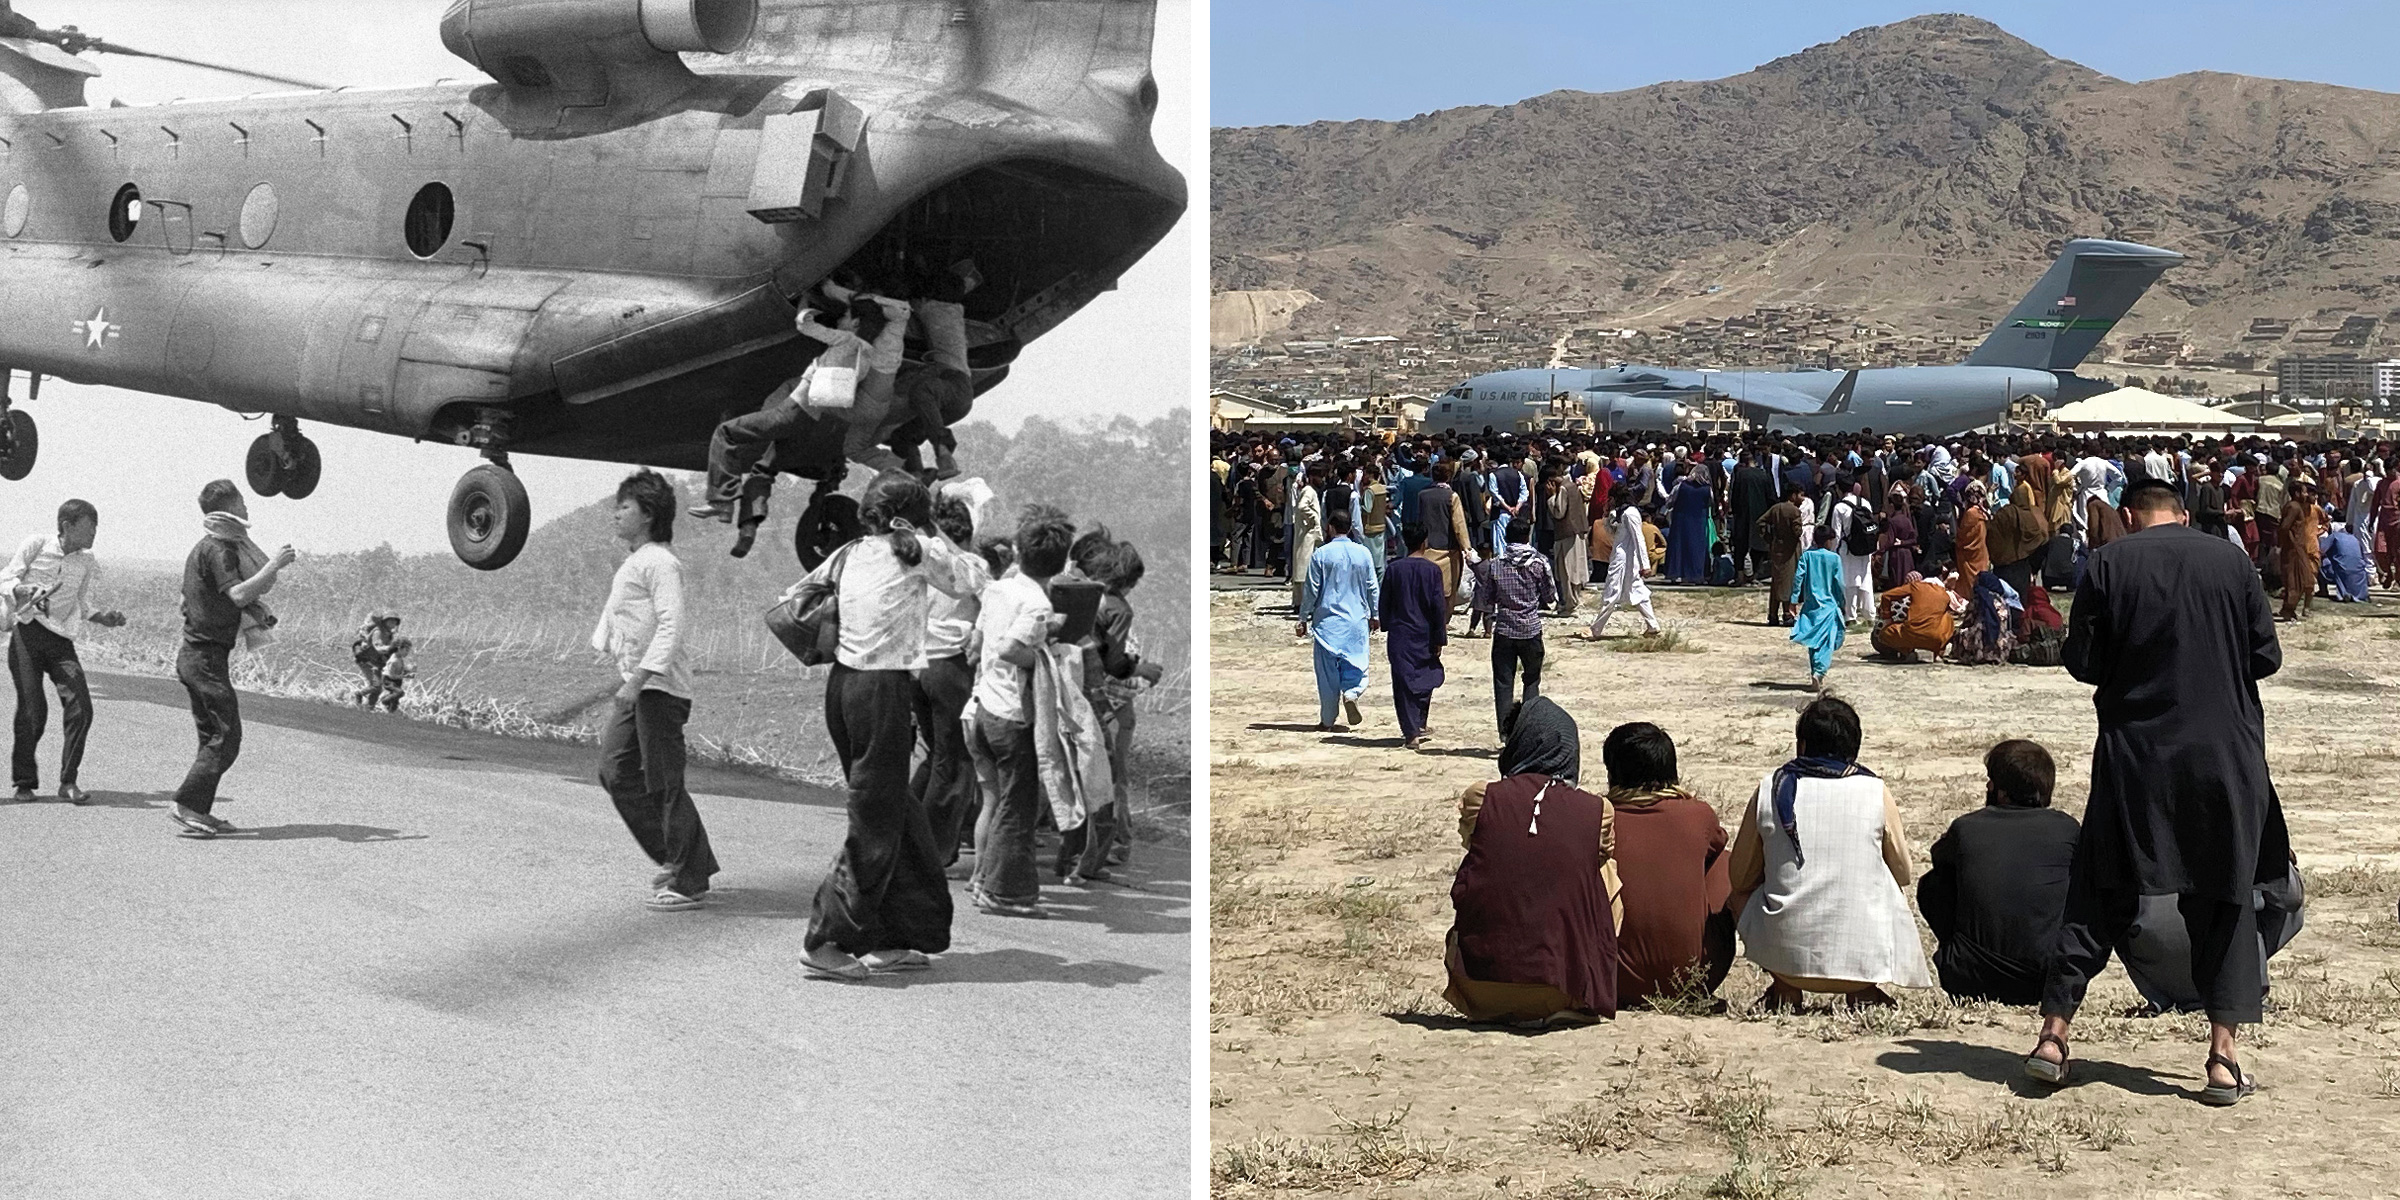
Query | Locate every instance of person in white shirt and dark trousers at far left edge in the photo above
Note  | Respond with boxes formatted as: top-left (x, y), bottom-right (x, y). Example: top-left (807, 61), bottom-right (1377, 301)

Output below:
top-left (0, 499), bottom-right (125, 804)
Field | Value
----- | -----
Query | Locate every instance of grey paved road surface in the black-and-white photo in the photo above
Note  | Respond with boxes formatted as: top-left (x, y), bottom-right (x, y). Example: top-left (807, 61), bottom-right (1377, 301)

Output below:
top-left (0, 674), bottom-right (1193, 1200)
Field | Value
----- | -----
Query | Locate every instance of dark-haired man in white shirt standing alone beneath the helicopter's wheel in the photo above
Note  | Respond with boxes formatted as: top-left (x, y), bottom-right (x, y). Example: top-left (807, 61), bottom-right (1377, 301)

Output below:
top-left (593, 470), bottom-right (718, 912)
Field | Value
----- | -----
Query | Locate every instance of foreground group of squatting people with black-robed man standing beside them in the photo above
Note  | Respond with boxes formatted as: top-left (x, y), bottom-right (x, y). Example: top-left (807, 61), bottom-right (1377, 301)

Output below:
top-left (1411, 475), bottom-right (2302, 1104)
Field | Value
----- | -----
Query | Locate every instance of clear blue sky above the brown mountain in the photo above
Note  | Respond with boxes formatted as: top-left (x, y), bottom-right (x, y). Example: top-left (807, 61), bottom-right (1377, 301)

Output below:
top-left (1210, 0), bottom-right (2400, 125)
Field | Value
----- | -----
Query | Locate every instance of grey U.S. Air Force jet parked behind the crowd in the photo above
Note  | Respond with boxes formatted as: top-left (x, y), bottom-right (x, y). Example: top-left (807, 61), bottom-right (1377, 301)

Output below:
top-left (1426, 238), bottom-right (2184, 437)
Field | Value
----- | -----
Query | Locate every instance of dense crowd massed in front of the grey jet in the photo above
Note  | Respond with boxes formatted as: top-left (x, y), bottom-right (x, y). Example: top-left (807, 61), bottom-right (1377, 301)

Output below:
top-left (1207, 432), bottom-right (2400, 700)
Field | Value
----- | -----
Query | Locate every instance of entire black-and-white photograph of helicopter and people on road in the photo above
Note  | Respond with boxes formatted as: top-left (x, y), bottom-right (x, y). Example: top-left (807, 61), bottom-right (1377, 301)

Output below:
top-left (0, 0), bottom-right (1205, 1200)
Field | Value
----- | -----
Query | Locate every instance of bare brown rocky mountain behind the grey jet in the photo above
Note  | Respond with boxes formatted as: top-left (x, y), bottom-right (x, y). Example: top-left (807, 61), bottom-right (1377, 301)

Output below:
top-left (1210, 14), bottom-right (2400, 358)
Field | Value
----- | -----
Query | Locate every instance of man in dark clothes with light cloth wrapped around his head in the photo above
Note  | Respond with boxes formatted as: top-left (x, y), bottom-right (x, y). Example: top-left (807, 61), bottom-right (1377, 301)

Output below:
top-left (168, 480), bottom-right (298, 838)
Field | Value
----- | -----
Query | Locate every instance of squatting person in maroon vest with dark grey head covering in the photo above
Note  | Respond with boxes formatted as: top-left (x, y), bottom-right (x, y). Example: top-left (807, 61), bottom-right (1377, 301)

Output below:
top-left (1442, 696), bottom-right (1618, 1025)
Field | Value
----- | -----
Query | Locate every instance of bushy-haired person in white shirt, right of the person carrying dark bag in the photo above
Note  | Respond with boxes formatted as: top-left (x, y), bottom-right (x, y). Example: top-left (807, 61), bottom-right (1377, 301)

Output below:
top-left (967, 509), bottom-right (1075, 917)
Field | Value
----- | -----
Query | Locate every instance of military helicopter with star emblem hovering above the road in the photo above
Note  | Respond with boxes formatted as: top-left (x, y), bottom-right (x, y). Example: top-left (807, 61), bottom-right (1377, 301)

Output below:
top-left (0, 0), bottom-right (1186, 569)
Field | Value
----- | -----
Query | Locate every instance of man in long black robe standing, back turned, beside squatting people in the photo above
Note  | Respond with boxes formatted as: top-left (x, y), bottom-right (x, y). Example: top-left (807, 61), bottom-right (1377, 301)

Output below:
top-left (2026, 480), bottom-right (2290, 1104)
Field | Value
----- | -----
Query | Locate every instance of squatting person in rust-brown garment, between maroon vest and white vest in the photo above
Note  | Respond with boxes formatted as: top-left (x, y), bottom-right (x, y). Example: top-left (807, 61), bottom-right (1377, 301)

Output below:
top-left (1601, 722), bottom-right (1733, 1008)
